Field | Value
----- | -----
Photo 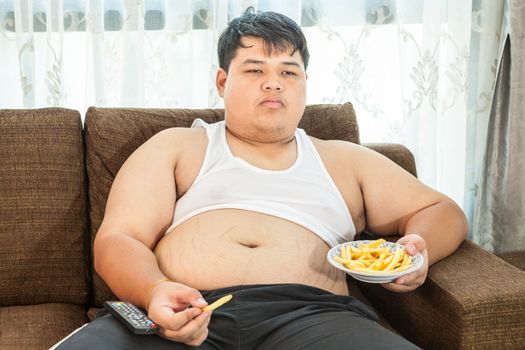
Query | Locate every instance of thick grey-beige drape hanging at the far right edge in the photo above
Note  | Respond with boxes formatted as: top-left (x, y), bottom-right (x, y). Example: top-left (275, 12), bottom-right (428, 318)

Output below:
top-left (473, 0), bottom-right (525, 253)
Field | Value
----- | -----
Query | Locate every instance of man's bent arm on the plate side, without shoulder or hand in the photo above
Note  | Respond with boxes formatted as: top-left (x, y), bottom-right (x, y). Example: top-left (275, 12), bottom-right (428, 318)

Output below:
top-left (358, 144), bottom-right (467, 264)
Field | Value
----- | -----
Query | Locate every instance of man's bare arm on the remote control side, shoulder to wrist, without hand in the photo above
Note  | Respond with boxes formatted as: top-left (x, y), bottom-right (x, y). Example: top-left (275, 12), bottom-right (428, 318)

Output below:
top-left (94, 129), bottom-right (181, 307)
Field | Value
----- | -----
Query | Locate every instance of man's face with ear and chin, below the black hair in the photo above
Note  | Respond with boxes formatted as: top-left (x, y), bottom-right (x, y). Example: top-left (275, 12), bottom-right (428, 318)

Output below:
top-left (217, 37), bottom-right (306, 142)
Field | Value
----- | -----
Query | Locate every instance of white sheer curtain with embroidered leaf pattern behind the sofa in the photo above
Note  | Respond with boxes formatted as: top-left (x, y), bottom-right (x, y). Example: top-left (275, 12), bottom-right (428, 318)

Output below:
top-left (0, 0), bottom-right (503, 227)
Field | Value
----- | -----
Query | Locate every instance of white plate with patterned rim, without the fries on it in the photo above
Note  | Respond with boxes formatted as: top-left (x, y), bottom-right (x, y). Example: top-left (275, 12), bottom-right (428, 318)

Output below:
top-left (326, 241), bottom-right (424, 283)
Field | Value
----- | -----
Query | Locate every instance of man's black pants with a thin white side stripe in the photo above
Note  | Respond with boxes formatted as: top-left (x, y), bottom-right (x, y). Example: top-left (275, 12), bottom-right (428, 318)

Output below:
top-left (58, 284), bottom-right (418, 350)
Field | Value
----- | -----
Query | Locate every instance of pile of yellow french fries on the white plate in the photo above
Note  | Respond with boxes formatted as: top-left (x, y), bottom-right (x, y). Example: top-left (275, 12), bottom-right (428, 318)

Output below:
top-left (335, 239), bottom-right (412, 273)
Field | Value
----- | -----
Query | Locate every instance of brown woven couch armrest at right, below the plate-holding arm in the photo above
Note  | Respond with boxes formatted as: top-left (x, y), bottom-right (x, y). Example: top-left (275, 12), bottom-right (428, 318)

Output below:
top-left (359, 241), bottom-right (525, 349)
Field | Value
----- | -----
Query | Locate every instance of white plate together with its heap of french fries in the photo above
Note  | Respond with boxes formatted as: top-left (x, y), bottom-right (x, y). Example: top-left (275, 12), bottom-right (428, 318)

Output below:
top-left (327, 239), bottom-right (424, 283)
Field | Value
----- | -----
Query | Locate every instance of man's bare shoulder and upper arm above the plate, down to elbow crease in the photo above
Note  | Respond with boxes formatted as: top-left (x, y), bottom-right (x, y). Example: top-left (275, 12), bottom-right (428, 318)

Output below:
top-left (312, 139), bottom-right (447, 234)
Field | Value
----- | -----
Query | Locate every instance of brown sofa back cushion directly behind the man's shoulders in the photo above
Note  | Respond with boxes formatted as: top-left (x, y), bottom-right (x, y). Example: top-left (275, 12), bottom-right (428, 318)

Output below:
top-left (85, 103), bottom-right (359, 307)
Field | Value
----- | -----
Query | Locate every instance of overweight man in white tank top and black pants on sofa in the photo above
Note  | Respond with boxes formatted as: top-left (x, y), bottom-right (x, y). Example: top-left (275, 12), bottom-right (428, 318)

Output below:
top-left (59, 9), bottom-right (467, 349)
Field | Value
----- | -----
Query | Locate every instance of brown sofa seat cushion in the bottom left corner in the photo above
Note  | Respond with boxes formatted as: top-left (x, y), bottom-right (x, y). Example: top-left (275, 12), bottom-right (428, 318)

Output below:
top-left (0, 304), bottom-right (87, 350)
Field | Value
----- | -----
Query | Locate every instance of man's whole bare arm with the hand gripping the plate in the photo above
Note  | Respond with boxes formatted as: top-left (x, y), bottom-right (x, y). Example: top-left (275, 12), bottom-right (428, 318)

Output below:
top-left (331, 141), bottom-right (467, 291)
